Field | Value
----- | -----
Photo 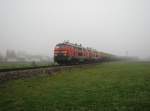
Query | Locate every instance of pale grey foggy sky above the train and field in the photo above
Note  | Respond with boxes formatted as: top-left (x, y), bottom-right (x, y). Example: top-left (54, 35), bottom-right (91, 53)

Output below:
top-left (0, 0), bottom-right (150, 57)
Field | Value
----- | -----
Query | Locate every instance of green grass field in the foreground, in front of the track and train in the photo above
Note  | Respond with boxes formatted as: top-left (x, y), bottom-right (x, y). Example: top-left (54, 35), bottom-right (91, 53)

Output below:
top-left (0, 62), bottom-right (150, 111)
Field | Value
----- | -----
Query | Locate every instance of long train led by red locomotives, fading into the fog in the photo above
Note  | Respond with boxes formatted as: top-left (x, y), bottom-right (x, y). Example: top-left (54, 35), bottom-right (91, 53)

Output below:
top-left (54, 42), bottom-right (116, 65)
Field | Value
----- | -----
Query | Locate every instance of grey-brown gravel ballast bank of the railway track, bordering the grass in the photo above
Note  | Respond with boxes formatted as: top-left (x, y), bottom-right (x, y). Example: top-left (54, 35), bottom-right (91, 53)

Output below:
top-left (0, 64), bottom-right (97, 83)
